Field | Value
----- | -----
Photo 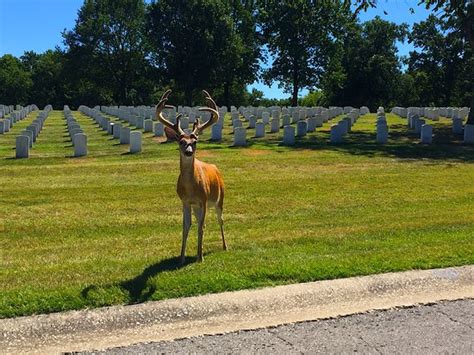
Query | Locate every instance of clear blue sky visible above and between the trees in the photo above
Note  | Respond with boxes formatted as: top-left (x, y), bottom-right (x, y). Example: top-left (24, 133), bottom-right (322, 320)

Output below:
top-left (0, 0), bottom-right (430, 99)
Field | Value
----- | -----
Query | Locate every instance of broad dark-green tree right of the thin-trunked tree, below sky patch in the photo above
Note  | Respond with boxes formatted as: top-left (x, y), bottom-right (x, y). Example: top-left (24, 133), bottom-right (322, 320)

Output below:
top-left (323, 17), bottom-right (407, 110)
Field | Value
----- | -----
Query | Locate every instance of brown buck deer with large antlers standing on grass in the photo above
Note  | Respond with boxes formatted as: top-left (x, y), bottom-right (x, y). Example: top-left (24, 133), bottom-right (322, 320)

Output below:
top-left (156, 90), bottom-right (227, 264)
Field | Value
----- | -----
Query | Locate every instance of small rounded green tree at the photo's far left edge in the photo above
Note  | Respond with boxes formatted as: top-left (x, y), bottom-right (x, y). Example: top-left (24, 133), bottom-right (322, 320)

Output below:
top-left (0, 54), bottom-right (32, 105)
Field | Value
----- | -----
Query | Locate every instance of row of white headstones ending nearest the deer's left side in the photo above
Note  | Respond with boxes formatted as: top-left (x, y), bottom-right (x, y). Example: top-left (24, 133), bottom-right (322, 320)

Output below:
top-left (79, 105), bottom-right (143, 154)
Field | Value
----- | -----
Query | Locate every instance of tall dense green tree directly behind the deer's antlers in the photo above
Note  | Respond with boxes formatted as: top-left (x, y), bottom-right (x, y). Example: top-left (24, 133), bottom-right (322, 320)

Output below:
top-left (148, 0), bottom-right (259, 105)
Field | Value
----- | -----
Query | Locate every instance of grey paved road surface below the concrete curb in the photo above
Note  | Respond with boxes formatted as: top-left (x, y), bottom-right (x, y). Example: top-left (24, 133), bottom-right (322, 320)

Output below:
top-left (93, 299), bottom-right (474, 354)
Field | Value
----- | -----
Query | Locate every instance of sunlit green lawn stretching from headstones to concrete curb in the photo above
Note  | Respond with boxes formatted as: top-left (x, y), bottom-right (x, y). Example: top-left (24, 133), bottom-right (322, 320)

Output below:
top-left (0, 111), bottom-right (474, 317)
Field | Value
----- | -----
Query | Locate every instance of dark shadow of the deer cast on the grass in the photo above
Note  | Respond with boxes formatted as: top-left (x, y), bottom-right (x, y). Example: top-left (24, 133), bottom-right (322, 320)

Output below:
top-left (81, 257), bottom-right (197, 304)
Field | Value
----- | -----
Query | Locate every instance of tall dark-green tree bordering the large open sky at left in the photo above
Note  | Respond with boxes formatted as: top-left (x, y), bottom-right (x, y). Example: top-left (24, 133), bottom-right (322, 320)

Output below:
top-left (63, 0), bottom-right (153, 105)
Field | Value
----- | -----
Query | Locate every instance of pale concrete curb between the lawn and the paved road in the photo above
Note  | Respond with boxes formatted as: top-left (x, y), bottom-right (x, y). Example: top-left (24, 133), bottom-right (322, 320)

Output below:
top-left (0, 265), bottom-right (474, 354)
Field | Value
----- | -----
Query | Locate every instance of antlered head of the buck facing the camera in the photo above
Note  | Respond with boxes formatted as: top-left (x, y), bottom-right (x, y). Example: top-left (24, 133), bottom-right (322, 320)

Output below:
top-left (156, 90), bottom-right (219, 158)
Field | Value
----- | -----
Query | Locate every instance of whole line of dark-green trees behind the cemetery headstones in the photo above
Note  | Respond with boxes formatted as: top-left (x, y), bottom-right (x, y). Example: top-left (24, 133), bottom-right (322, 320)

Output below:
top-left (0, 0), bottom-right (474, 109)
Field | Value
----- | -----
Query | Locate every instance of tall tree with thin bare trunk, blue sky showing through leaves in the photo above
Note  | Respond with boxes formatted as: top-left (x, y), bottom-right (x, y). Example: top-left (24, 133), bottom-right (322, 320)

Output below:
top-left (259, 0), bottom-right (340, 106)
